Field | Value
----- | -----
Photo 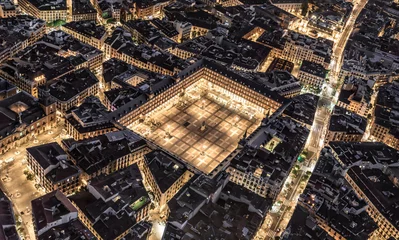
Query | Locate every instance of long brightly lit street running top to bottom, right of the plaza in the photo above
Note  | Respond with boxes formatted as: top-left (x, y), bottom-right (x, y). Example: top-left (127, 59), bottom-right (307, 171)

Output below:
top-left (256, 0), bottom-right (367, 240)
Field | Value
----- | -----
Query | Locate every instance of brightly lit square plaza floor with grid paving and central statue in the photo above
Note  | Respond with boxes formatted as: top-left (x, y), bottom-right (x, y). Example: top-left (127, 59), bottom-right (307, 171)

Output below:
top-left (131, 97), bottom-right (259, 174)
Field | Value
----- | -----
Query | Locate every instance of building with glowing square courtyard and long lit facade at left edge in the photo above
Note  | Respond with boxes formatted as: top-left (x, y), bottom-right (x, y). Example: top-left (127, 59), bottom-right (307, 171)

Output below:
top-left (0, 92), bottom-right (56, 154)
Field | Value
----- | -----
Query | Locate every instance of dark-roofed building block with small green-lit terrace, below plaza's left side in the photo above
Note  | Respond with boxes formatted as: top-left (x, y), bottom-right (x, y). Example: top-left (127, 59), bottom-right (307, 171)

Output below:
top-left (69, 164), bottom-right (151, 240)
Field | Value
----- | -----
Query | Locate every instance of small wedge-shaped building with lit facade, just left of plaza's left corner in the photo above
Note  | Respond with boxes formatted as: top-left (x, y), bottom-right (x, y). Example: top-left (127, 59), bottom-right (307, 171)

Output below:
top-left (65, 96), bottom-right (117, 141)
